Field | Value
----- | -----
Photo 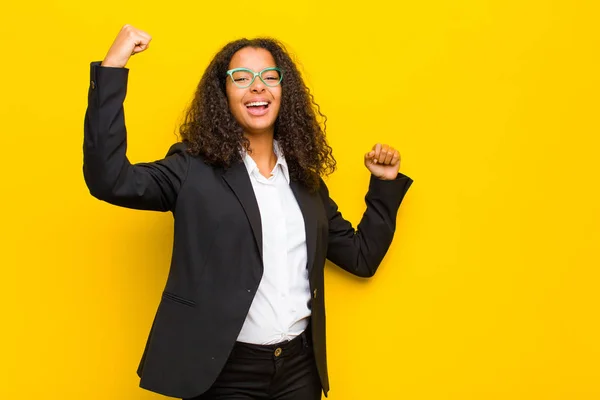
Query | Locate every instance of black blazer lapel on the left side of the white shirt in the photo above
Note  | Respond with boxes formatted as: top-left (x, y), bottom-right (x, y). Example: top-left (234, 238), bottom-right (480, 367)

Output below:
top-left (223, 161), bottom-right (263, 259)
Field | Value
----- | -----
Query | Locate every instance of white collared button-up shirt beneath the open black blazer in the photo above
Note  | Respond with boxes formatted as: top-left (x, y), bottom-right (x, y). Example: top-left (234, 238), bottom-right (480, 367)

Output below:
top-left (237, 141), bottom-right (310, 344)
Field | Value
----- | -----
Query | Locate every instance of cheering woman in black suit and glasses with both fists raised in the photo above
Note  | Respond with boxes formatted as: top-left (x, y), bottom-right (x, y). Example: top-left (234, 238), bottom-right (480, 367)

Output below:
top-left (84, 25), bottom-right (412, 400)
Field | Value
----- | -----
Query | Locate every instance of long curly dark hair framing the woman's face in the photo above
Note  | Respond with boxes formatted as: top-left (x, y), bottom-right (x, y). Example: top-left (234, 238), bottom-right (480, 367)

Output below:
top-left (179, 38), bottom-right (336, 191)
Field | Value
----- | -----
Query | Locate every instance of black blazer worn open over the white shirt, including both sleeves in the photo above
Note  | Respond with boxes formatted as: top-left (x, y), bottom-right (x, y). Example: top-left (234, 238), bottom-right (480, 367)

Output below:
top-left (83, 63), bottom-right (412, 398)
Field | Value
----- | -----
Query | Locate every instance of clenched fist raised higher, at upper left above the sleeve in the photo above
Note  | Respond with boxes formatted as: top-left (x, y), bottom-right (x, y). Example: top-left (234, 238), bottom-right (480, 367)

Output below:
top-left (102, 25), bottom-right (152, 68)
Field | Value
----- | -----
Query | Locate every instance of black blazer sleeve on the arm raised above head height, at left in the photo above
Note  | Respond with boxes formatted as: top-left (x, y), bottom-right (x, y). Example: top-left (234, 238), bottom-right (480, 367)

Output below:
top-left (83, 62), bottom-right (190, 211)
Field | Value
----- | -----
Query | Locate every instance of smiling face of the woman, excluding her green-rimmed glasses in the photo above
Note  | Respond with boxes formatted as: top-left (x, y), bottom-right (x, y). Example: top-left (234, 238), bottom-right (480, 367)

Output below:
top-left (226, 47), bottom-right (281, 135)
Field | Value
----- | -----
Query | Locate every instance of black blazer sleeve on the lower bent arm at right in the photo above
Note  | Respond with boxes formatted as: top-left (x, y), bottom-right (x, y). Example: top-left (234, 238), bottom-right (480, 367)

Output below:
top-left (321, 173), bottom-right (413, 277)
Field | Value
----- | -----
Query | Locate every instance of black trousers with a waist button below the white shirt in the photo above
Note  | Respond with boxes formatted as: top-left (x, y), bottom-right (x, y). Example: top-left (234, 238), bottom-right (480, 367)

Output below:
top-left (183, 327), bottom-right (321, 400)
